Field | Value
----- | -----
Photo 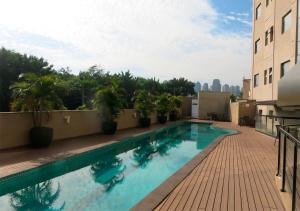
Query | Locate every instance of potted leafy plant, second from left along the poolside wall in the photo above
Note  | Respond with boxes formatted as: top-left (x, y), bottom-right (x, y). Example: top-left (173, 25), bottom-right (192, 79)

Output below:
top-left (94, 83), bottom-right (123, 134)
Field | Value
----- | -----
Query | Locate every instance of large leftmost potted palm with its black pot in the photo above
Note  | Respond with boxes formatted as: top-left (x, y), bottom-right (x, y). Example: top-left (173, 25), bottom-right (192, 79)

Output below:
top-left (10, 73), bottom-right (63, 148)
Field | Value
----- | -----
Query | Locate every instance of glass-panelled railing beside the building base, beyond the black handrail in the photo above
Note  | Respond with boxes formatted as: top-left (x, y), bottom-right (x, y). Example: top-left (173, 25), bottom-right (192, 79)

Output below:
top-left (255, 115), bottom-right (300, 137)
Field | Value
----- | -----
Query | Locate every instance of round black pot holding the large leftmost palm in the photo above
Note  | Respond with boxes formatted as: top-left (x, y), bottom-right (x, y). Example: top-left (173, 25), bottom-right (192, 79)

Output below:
top-left (29, 127), bottom-right (53, 148)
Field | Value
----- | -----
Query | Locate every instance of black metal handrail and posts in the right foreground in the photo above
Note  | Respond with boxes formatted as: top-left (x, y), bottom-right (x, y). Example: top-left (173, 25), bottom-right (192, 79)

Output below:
top-left (276, 124), bottom-right (300, 211)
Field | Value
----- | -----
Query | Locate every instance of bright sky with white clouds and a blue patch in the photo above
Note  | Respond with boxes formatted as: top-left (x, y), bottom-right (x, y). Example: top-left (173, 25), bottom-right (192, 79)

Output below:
top-left (0, 0), bottom-right (252, 84)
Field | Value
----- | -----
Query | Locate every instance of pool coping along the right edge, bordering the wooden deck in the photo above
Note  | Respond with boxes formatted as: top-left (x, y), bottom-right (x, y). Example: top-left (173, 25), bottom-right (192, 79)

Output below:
top-left (130, 120), bottom-right (241, 211)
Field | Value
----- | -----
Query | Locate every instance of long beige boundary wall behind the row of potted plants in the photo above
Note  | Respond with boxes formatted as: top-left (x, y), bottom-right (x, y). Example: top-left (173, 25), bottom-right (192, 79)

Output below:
top-left (0, 109), bottom-right (157, 150)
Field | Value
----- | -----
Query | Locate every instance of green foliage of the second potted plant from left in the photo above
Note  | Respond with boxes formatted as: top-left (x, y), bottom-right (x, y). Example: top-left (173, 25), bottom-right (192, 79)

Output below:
top-left (94, 83), bottom-right (124, 122)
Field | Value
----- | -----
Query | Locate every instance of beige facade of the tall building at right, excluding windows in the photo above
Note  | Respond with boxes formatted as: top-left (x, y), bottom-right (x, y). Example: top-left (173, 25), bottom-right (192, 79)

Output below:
top-left (251, 0), bottom-right (297, 101)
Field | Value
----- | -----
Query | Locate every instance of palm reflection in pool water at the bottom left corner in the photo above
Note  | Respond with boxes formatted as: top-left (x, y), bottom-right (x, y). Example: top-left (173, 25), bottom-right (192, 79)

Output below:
top-left (10, 180), bottom-right (65, 211)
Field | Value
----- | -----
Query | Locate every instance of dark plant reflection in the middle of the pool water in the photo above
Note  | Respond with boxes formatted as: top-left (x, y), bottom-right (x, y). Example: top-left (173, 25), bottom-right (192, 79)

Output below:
top-left (91, 155), bottom-right (126, 191)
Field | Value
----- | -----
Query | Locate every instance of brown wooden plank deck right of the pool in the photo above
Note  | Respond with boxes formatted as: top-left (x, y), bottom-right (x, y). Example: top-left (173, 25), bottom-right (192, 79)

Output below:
top-left (156, 123), bottom-right (284, 211)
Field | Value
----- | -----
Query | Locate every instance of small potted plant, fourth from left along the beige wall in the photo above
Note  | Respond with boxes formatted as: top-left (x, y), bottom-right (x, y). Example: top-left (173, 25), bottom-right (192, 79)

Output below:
top-left (156, 93), bottom-right (170, 124)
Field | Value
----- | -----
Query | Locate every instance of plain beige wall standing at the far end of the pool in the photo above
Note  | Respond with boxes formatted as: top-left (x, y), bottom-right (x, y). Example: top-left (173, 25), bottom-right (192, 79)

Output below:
top-left (198, 92), bottom-right (231, 119)
